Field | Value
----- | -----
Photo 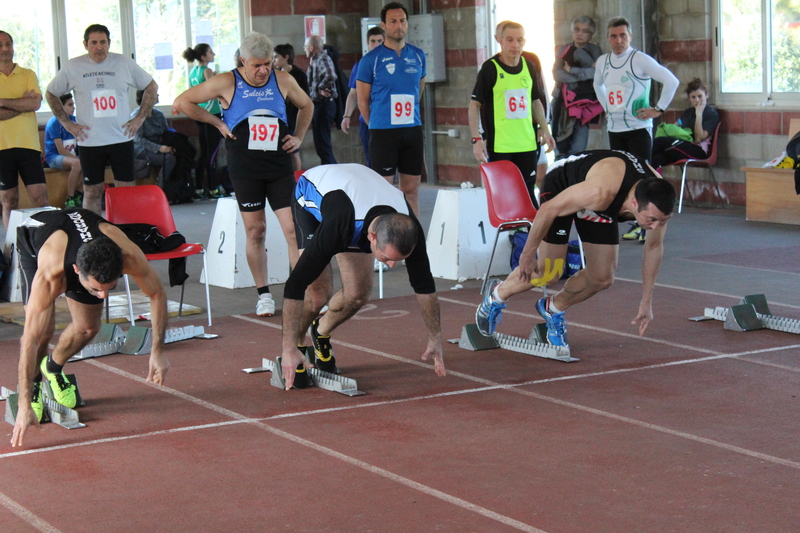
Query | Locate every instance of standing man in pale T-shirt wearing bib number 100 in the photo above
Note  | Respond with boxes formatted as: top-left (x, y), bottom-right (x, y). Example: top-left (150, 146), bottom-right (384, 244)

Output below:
top-left (45, 24), bottom-right (158, 214)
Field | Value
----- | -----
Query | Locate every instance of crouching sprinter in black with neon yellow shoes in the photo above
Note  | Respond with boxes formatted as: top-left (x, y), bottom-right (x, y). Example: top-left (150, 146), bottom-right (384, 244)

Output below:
top-left (11, 209), bottom-right (169, 446)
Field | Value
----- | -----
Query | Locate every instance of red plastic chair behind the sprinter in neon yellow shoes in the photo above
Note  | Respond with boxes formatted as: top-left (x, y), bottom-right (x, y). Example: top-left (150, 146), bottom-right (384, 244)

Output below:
top-left (106, 185), bottom-right (211, 326)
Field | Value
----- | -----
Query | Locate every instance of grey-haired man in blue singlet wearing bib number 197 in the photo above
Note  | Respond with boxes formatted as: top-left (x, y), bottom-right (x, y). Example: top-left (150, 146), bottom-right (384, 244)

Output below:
top-left (173, 33), bottom-right (313, 316)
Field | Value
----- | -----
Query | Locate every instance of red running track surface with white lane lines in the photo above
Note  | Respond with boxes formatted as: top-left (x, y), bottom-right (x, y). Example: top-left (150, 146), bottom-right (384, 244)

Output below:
top-left (0, 282), bottom-right (800, 533)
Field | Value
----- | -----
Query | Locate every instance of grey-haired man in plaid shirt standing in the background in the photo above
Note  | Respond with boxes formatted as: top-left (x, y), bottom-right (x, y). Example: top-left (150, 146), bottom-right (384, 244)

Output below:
top-left (303, 35), bottom-right (338, 165)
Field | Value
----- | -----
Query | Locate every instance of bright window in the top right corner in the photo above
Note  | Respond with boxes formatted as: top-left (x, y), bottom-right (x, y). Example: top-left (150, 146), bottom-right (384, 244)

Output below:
top-left (717, 0), bottom-right (800, 105)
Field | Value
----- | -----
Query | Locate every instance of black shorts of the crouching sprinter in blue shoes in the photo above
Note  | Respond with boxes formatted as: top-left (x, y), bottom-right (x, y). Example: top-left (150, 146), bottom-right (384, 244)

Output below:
top-left (540, 166), bottom-right (619, 245)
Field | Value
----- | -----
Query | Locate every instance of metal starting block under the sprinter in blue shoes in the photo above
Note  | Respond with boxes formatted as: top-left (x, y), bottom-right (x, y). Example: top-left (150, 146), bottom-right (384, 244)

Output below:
top-left (458, 324), bottom-right (580, 363)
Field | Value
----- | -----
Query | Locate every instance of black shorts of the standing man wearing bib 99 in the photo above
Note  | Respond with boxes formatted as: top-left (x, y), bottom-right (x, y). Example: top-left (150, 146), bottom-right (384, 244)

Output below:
top-left (369, 126), bottom-right (424, 176)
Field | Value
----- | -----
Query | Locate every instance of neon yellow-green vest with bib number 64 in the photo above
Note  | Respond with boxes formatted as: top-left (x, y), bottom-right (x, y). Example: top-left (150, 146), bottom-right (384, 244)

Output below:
top-left (492, 57), bottom-right (537, 154)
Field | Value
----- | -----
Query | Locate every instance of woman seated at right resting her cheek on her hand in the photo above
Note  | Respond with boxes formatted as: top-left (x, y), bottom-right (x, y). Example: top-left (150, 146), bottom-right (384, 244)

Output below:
top-left (651, 78), bottom-right (719, 169)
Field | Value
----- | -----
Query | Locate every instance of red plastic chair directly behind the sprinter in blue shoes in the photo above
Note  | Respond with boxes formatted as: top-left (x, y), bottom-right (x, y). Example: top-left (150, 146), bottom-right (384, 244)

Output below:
top-left (481, 161), bottom-right (536, 294)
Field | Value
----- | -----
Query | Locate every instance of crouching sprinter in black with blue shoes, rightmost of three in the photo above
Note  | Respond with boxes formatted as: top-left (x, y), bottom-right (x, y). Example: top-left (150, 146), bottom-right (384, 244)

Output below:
top-left (476, 150), bottom-right (675, 346)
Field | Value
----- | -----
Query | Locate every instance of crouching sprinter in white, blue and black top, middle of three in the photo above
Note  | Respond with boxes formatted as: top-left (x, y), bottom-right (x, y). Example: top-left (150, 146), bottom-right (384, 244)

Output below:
top-left (282, 164), bottom-right (445, 390)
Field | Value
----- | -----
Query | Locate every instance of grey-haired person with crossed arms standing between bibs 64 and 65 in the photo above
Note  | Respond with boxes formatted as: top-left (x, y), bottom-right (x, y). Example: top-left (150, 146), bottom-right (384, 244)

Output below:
top-left (551, 15), bottom-right (603, 159)
